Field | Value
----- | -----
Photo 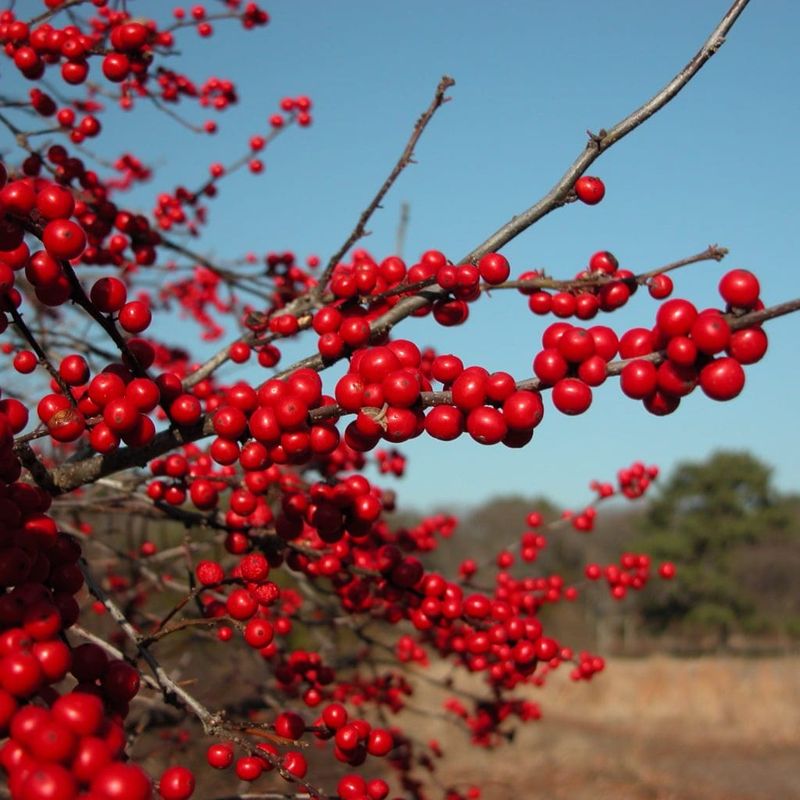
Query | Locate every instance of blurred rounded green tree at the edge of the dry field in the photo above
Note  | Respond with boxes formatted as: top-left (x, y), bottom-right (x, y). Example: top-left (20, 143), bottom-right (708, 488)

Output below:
top-left (637, 451), bottom-right (794, 645)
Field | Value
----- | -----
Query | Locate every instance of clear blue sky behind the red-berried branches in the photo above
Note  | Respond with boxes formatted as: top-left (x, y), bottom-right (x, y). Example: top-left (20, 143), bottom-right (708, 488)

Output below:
top-left (7, 0), bottom-right (800, 507)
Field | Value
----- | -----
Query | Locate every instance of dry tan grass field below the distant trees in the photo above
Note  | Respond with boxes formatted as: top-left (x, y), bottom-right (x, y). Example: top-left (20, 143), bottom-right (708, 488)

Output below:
top-left (409, 656), bottom-right (800, 800)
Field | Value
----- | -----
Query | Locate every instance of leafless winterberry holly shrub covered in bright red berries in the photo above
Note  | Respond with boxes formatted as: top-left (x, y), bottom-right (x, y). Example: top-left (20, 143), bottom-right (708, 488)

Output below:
top-left (0, 0), bottom-right (800, 800)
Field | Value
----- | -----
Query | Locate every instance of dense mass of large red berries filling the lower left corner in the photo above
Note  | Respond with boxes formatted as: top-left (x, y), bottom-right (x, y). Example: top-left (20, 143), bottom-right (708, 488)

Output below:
top-left (0, 401), bottom-right (202, 800)
